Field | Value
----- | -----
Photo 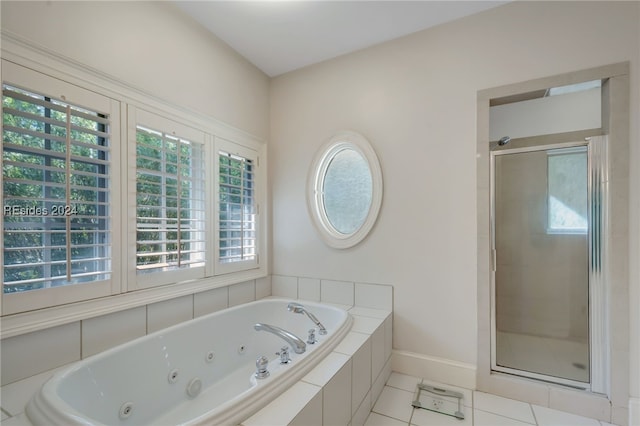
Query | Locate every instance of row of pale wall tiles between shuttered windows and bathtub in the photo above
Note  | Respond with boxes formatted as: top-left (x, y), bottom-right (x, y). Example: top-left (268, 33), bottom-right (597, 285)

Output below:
top-left (0, 277), bottom-right (271, 388)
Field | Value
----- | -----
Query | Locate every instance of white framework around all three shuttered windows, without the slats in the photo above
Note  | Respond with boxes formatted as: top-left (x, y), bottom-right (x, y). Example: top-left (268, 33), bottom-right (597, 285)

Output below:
top-left (0, 39), bottom-right (269, 339)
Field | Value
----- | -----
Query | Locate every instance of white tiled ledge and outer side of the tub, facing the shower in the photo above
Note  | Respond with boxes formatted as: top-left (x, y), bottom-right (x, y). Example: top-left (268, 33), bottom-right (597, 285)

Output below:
top-left (242, 307), bottom-right (392, 426)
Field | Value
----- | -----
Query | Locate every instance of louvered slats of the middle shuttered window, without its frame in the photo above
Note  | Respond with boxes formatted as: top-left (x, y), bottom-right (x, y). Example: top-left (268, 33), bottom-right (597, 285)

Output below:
top-left (136, 126), bottom-right (205, 274)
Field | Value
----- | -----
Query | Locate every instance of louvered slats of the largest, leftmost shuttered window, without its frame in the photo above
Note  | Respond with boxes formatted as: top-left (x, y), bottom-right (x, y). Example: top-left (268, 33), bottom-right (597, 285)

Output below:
top-left (2, 84), bottom-right (112, 294)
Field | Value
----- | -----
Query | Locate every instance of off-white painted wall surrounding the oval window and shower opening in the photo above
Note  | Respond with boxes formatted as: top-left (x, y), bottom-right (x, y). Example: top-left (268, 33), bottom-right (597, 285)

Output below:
top-left (269, 2), bottom-right (640, 396)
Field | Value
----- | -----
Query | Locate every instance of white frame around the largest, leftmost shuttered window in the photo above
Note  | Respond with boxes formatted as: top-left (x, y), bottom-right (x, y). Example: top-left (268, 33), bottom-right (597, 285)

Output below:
top-left (0, 59), bottom-right (121, 315)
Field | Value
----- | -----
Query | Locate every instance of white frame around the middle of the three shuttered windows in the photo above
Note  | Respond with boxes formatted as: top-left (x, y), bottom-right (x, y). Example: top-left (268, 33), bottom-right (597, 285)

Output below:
top-left (127, 106), bottom-right (211, 290)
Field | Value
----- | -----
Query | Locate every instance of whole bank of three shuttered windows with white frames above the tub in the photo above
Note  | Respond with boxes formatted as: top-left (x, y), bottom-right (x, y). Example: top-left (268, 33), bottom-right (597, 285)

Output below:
top-left (0, 57), bottom-right (268, 326)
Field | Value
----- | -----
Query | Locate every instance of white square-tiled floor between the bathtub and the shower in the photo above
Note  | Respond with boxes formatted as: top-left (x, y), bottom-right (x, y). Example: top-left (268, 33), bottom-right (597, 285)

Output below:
top-left (365, 372), bottom-right (610, 426)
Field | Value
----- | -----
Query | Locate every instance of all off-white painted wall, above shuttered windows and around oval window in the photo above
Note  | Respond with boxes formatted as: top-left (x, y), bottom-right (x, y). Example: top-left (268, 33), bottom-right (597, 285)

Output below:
top-left (0, 1), bottom-right (640, 420)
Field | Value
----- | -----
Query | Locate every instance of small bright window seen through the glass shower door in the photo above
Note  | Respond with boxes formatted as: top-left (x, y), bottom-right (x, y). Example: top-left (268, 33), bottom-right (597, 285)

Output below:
top-left (547, 147), bottom-right (588, 234)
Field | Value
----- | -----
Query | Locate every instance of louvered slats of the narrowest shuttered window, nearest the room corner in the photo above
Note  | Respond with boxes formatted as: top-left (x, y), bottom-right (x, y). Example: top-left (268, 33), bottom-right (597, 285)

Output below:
top-left (218, 150), bottom-right (258, 264)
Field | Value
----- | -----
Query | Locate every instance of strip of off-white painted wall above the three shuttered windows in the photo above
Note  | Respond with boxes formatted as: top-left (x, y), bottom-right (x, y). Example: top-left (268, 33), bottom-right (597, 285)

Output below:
top-left (1, 1), bottom-right (269, 140)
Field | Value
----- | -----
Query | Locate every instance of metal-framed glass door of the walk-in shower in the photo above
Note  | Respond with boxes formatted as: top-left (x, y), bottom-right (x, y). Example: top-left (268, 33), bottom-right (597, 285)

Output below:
top-left (492, 144), bottom-right (590, 387)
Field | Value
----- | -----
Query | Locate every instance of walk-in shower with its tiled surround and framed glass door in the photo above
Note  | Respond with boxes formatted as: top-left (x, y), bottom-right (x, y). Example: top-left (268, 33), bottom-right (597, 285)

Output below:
top-left (476, 63), bottom-right (634, 423)
